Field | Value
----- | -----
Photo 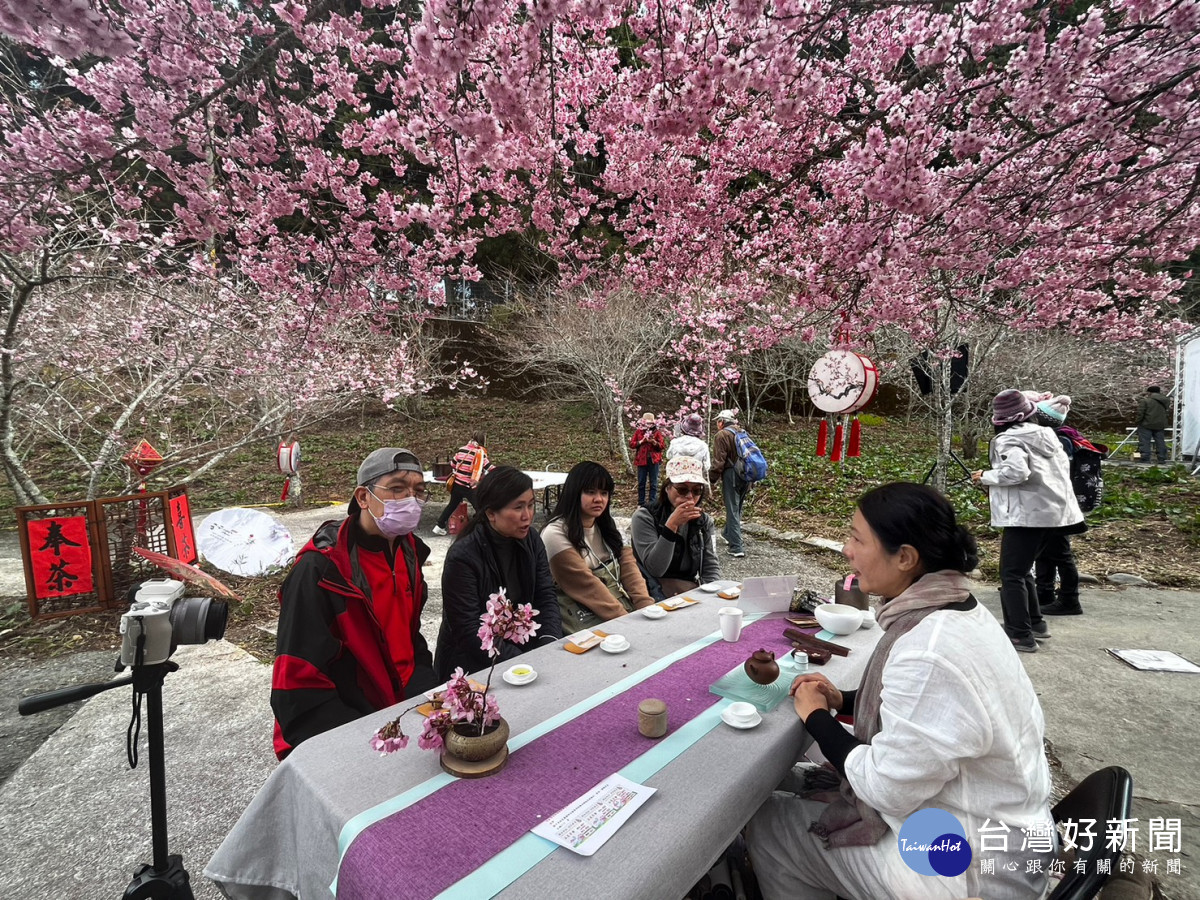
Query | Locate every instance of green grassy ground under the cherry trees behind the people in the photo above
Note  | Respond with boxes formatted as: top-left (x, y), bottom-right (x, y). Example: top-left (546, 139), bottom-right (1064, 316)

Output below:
top-left (0, 396), bottom-right (1200, 586)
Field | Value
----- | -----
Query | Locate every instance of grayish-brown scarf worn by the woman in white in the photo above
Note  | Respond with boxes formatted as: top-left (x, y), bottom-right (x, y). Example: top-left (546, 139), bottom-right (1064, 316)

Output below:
top-left (800, 569), bottom-right (971, 850)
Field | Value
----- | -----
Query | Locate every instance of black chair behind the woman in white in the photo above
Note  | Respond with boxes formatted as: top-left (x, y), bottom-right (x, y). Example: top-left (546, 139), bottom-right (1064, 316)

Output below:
top-left (1048, 766), bottom-right (1133, 900)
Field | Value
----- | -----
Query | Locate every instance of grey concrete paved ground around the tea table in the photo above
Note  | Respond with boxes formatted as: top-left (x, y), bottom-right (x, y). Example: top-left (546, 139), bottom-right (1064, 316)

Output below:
top-left (0, 504), bottom-right (1200, 900)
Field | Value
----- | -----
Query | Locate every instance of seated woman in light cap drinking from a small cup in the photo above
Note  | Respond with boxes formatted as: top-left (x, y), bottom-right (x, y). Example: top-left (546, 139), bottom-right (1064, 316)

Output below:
top-left (631, 456), bottom-right (721, 600)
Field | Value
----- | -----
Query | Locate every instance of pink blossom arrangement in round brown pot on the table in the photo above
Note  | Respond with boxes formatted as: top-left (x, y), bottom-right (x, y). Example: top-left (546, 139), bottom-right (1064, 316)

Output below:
top-left (371, 587), bottom-right (540, 775)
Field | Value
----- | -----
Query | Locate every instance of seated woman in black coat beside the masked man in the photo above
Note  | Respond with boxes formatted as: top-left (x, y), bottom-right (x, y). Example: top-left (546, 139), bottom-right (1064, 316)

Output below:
top-left (433, 466), bottom-right (563, 678)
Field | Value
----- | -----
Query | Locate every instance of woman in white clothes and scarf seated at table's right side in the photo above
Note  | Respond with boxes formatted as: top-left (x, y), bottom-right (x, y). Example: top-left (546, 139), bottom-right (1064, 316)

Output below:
top-left (748, 484), bottom-right (1054, 900)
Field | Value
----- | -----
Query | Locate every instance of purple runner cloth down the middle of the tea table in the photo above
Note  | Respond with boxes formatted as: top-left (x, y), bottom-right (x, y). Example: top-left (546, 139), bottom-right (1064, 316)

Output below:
top-left (337, 617), bottom-right (791, 900)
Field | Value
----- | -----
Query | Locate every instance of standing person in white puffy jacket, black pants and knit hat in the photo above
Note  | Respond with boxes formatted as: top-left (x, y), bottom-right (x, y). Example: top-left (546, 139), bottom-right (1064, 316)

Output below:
top-left (971, 390), bottom-right (1084, 653)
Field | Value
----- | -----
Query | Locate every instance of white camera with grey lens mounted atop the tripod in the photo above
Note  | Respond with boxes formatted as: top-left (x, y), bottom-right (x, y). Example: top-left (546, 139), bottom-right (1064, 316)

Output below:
top-left (121, 578), bottom-right (229, 666)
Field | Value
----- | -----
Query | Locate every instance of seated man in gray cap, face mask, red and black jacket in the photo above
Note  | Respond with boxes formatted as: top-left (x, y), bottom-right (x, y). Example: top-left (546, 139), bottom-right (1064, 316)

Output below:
top-left (271, 446), bottom-right (437, 760)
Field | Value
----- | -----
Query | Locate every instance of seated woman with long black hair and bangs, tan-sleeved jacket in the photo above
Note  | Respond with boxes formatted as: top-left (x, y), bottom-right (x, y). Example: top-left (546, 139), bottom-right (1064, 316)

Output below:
top-left (541, 462), bottom-right (654, 631)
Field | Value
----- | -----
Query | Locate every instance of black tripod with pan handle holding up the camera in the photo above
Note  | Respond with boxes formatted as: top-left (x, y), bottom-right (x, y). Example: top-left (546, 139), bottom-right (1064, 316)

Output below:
top-left (18, 660), bottom-right (193, 900)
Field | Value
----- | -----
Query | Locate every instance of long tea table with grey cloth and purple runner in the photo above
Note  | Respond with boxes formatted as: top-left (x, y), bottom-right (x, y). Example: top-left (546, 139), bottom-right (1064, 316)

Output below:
top-left (204, 577), bottom-right (881, 900)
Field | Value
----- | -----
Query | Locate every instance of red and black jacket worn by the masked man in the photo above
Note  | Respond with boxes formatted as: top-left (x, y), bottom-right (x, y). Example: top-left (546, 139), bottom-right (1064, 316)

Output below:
top-left (271, 516), bottom-right (433, 760)
